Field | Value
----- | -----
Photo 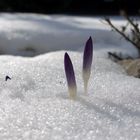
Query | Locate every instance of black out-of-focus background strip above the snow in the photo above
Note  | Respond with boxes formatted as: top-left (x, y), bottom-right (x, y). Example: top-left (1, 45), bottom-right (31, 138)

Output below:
top-left (0, 0), bottom-right (140, 15)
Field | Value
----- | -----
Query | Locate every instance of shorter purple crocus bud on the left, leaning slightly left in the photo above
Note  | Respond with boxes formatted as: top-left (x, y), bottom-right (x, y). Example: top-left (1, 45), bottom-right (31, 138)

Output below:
top-left (64, 53), bottom-right (77, 99)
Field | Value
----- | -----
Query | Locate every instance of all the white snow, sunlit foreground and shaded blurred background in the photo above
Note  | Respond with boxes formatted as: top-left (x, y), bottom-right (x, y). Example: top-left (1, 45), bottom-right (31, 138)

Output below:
top-left (0, 13), bottom-right (140, 140)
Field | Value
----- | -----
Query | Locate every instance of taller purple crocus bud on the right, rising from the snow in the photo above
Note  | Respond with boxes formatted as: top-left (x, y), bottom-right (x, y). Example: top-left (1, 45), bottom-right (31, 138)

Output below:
top-left (83, 37), bottom-right (93, 93)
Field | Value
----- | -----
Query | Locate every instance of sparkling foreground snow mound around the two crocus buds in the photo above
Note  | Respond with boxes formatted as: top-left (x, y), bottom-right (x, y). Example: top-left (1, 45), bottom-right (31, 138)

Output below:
top-left (0, 51), bottom-right (140, 140)
